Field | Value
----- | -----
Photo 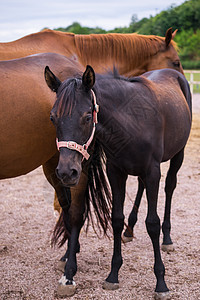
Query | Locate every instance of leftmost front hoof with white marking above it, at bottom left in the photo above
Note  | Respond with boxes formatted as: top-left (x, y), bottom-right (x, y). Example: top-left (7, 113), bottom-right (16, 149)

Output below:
top-left (57, 275), bottom-right (76, 297)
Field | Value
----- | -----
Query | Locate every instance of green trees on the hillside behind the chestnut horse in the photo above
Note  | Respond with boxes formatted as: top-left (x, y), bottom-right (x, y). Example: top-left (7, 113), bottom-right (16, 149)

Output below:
top-left (53, 0), bottom-right (200, 69)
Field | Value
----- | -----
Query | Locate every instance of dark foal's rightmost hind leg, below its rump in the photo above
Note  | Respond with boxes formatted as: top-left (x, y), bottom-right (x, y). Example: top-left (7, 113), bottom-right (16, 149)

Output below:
top-left (161, 148), bottom-right (184, 252)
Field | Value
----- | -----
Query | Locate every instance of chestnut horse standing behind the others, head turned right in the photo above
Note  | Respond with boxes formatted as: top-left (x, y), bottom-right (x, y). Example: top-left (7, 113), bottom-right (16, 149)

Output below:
top-left (0, 28), bottom-right (183, 76)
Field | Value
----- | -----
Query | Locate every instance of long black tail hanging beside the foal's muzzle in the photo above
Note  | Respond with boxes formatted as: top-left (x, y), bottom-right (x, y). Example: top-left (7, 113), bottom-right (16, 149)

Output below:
top-left (85, 140), bottom-right (112, 234)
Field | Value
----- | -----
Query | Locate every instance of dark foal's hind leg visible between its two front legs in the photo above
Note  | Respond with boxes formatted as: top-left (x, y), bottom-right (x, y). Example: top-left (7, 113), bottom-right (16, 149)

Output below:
top-left (122, 177), bottom-right (144, 243)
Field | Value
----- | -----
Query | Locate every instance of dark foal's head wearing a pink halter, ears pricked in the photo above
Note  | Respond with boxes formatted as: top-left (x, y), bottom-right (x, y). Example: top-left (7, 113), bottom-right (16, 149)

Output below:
top-left (45, 66), bottom-right (97, 186)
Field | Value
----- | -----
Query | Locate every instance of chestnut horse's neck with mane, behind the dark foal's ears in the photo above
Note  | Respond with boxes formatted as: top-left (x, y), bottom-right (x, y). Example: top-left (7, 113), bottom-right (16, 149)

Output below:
top-left (75, 34), bottom-right (163, 76)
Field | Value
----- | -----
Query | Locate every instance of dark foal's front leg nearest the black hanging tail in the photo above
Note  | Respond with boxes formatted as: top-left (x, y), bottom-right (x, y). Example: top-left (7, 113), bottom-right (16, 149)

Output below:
top-left (103, 164), bottom-right (127, 290)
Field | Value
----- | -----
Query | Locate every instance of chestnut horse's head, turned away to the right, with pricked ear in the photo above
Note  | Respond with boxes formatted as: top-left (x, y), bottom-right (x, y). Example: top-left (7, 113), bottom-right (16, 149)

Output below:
top-left (146, 28), bottom-right (184, 74)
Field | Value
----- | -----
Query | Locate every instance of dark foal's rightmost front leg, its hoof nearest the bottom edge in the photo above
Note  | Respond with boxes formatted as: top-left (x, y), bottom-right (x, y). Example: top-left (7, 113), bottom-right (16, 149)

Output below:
top-left (145, 162), bottom-right (169, 296)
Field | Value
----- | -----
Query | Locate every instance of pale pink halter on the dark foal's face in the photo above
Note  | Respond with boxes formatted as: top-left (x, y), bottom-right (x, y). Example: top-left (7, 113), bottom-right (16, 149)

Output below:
top-left (56, 90), bottom-right (99, 160)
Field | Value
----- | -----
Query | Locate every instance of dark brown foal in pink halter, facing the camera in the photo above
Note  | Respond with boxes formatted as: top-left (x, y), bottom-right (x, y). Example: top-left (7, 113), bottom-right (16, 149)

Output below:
top-left (45, 66), bottom-right (192, 299)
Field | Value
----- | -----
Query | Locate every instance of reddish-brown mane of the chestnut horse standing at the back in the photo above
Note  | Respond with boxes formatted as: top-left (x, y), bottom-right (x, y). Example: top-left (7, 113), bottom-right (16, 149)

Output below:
top-left (74, 33), bottom-right (177, 69)
